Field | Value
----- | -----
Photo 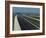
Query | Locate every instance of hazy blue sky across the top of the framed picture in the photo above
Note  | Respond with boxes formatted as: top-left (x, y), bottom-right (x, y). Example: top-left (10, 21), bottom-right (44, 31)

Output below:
top-left (13, 7), bottom-right (40, 14)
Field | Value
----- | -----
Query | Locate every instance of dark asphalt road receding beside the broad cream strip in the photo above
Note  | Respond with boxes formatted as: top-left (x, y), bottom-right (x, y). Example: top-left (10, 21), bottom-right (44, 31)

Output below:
top-left (17, 15), bottom-right (40, 30)
